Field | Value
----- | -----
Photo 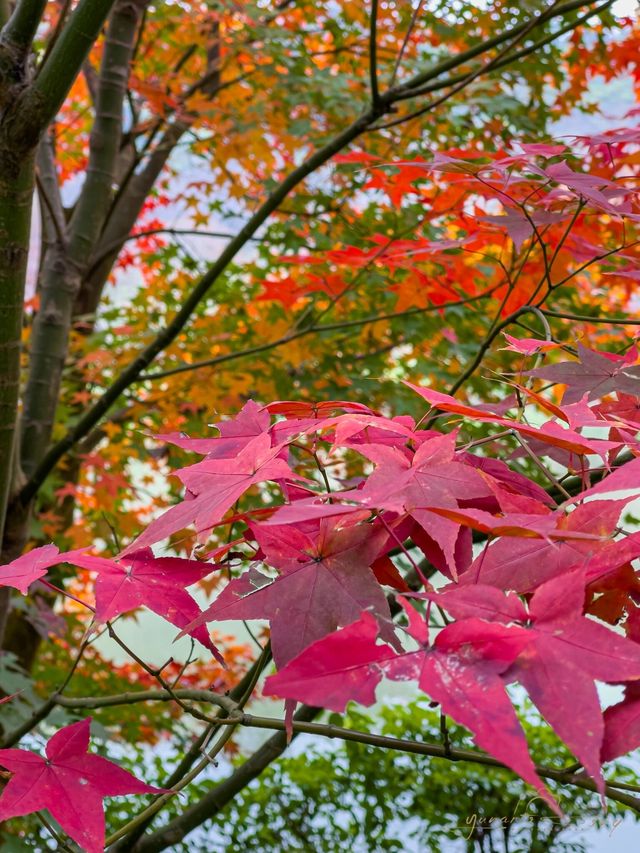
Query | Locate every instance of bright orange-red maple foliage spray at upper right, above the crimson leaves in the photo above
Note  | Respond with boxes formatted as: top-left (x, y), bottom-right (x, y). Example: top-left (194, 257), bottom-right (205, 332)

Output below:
top-left (280, 127), bottom-right (640, 316)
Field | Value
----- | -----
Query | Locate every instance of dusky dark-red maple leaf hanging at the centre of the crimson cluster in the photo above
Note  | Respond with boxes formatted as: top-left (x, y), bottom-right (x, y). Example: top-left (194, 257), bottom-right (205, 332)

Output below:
top-left (178, 519), bottom-right (390, 666)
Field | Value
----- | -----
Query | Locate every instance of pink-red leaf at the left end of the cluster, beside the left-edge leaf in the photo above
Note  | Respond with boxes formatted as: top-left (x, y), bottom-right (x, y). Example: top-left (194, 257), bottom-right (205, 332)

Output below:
top-left (66, 549), bottom-right (224, 665)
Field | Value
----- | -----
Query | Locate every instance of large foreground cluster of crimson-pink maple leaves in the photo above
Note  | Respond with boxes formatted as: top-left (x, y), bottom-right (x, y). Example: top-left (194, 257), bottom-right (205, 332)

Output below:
top-left (0, 336), bottom-right (640, 849)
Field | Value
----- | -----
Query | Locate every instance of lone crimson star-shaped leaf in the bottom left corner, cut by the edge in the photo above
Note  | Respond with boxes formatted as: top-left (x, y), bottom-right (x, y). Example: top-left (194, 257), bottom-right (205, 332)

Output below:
top-left (0, 717), bottom-right (162, 853)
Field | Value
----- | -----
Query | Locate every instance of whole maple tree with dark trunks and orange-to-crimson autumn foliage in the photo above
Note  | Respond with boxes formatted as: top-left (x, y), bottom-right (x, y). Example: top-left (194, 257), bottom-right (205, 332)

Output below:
top-left (0, 0), bottom-right (640, 851)
